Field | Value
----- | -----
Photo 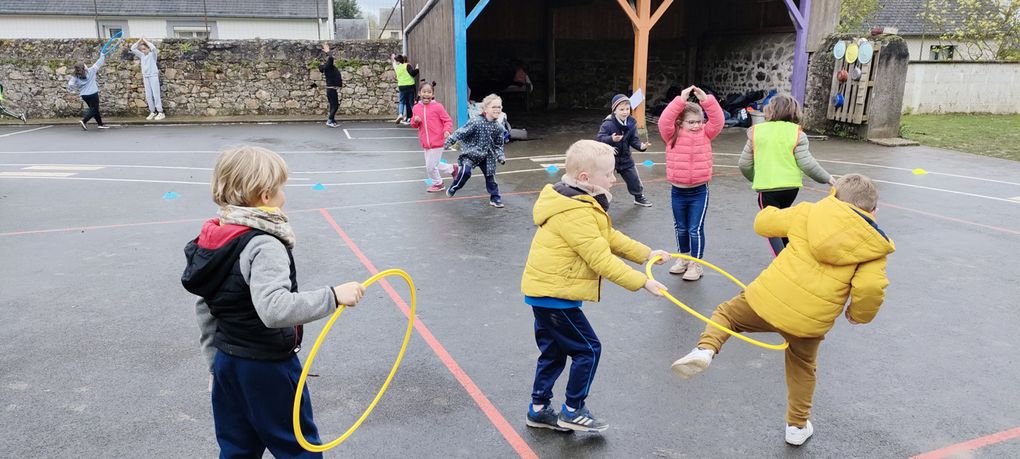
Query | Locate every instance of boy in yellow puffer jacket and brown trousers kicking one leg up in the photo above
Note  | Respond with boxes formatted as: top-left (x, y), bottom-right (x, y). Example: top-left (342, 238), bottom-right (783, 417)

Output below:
top-left (673, 173), bottom-right (896, 445)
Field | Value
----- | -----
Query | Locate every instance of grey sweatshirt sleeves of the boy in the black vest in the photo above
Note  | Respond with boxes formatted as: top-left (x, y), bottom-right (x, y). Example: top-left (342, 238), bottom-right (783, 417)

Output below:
top-left (195, 235), bottom-right (337, 372)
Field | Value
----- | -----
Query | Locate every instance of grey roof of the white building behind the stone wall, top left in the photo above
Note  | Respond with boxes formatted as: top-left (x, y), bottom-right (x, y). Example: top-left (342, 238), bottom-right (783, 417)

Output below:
top-left (0, 0), bottom-right (329, 19)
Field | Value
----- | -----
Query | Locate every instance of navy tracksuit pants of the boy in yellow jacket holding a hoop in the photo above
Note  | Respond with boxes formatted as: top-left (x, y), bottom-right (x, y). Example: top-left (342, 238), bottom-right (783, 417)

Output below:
top-left (531, 306), bottom-right (602, 409)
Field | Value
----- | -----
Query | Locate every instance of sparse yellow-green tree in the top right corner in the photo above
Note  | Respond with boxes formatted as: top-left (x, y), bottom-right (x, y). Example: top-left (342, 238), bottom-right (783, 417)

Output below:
top-left (922, 0), bottom-right (1020, 61)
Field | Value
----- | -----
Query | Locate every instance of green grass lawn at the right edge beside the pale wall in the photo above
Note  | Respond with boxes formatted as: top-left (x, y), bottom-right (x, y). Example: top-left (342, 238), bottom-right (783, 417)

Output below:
top-left (900, 114), bottom-right (1020, 161)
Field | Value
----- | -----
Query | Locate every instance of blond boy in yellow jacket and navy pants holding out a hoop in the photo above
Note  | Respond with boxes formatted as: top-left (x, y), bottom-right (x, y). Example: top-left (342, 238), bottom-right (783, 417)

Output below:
top-left (520, 140), bottom-right (669, 431)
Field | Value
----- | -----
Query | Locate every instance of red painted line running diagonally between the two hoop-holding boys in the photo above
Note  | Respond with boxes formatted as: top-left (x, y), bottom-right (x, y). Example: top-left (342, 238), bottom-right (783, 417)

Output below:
top-left (319, 208), bottom-right (539, 458)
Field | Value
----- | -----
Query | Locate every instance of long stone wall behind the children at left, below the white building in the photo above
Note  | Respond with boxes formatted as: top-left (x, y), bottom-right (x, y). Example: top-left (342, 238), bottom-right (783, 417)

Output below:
top-left (0, 39), bottom-right (400, 118)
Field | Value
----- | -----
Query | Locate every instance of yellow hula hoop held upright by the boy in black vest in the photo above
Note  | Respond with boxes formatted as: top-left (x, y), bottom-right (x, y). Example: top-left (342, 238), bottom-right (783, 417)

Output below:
top-left (293, 269), bottom-right (417, 453)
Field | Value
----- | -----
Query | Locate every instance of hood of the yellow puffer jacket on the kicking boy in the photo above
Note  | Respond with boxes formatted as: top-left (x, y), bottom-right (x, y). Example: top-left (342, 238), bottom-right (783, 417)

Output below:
top-left (806, 196), bottom-right (896, 266)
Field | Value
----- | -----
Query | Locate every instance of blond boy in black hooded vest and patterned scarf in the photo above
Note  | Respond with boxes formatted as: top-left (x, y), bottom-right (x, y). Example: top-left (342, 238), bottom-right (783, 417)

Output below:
top-left (181, 146), bottom-right (364, 457)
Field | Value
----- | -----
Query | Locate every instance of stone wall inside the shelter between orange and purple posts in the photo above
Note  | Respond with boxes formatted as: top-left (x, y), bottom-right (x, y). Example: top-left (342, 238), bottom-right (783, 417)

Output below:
top-left (697, 34), bottom-right (796, 97)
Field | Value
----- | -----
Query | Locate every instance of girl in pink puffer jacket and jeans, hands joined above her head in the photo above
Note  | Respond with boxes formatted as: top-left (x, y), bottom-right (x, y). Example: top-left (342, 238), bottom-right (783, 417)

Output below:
top-left (659, 86), bottom-right (723, 281)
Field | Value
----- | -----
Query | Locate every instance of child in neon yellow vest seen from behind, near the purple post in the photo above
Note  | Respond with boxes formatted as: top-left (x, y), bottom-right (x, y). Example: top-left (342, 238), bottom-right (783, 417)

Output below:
top-left (737, 94), bottom-right (834, 255)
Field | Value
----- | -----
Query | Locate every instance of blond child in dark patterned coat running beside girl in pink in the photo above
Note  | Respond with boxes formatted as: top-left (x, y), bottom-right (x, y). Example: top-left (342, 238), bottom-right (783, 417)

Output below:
top-left (446, 94), bottom-right (506, 208)
